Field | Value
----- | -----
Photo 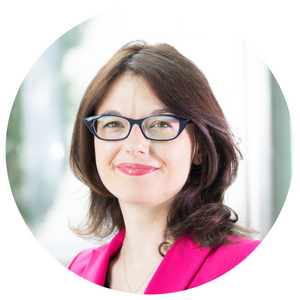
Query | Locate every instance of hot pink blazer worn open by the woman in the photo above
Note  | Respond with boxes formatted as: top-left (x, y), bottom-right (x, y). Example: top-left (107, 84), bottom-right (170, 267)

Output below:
top-left (69, 229), bottom-right (260, 294)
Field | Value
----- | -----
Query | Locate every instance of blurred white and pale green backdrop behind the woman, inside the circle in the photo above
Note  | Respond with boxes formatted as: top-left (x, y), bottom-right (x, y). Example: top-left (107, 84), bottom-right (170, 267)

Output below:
top-left (6, 11), bottom-right (292, 266)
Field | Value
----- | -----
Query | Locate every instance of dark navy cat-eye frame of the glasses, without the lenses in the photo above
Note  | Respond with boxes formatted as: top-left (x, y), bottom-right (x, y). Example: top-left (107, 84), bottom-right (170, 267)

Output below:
top-left (84, 115), bottom-right (192, 142)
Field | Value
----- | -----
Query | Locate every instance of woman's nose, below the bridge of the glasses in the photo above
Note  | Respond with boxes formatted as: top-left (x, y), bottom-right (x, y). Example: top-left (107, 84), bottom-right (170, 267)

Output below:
top-left (124, 124), bottom-right (149, 156)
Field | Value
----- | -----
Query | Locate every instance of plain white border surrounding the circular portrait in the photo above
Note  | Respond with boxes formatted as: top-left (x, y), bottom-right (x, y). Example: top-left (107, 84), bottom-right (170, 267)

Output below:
top-left (0, 0), bottom-right (300, 299)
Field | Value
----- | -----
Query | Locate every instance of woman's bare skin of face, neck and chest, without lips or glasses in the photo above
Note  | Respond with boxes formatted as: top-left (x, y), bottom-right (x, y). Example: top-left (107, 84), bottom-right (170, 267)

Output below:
top-left (94, 73), bottom-right (199, 293)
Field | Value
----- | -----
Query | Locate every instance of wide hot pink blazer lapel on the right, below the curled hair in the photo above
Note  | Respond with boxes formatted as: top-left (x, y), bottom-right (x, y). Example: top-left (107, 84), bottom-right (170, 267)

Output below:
top-left (145, 236), bottom-right (211, 294)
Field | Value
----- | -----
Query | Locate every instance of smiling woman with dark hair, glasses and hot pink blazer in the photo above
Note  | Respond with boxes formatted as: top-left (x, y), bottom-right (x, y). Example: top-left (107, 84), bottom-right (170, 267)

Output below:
top-left (69, 41), bottom-right (259, 294)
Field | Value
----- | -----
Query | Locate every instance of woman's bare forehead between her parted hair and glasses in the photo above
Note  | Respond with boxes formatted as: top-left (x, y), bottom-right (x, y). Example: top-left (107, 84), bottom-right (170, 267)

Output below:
top-left (96, 73), bottom-right (167, 117)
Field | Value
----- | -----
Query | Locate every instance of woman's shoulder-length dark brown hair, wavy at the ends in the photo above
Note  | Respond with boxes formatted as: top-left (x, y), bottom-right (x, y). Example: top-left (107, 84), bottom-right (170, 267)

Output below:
top-left (70, 41), bottom-right (254, 255)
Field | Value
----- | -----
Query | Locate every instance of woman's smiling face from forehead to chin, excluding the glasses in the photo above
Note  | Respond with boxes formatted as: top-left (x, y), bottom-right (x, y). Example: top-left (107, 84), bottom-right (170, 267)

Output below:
top-left (95, 73), bottom-right (194, 206)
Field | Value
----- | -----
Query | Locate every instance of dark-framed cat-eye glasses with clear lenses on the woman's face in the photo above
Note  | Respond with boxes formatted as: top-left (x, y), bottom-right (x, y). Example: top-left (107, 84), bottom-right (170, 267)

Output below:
top-left (84, 115), bottom-right (191, 141)
